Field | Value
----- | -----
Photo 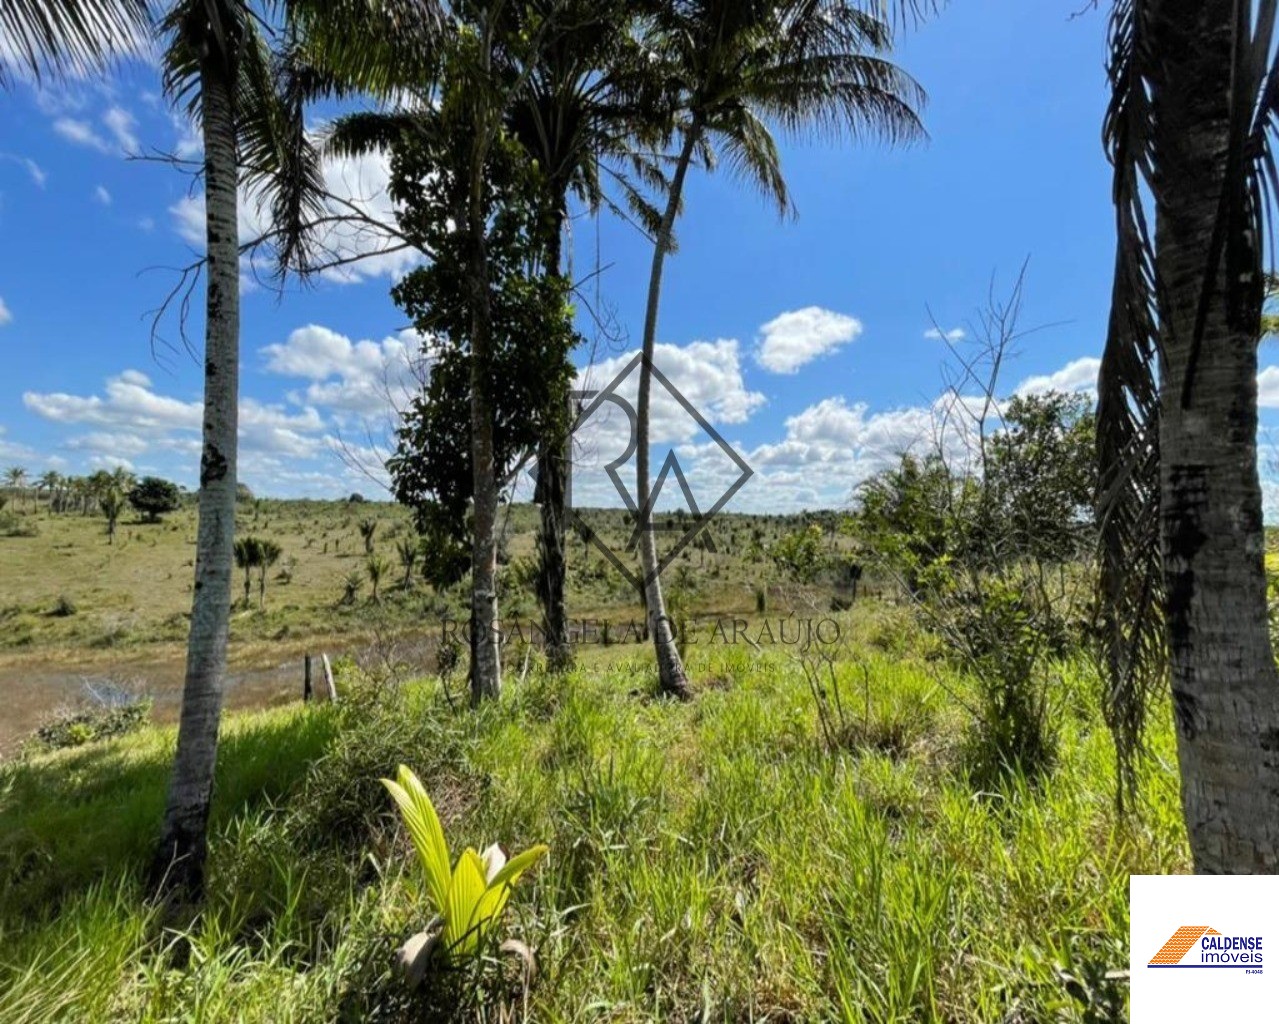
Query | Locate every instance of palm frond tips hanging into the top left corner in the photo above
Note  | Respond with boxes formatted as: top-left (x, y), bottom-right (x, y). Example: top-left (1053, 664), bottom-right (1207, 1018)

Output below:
top-left (0, 0), bottom-right (150, 87)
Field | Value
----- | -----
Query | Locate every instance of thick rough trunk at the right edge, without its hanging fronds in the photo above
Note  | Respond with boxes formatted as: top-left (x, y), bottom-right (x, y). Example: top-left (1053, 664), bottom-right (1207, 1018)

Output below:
top-left (1150, 0), bottom-right (1279, 874)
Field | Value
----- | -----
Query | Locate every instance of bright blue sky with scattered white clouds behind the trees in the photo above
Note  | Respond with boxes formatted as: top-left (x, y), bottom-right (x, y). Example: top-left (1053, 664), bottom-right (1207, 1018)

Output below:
top-left (0, 0), bottom-right (1279, 510)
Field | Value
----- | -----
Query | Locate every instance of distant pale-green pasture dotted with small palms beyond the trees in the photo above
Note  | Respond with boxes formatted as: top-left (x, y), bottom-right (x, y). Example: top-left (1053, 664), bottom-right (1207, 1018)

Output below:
top-left (0, 500), bottom-right (848, 756)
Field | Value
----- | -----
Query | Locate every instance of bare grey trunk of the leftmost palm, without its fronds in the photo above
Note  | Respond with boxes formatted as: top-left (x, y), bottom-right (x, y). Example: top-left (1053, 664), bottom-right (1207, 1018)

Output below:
top-left (152, 55), bottom-right (239, 900)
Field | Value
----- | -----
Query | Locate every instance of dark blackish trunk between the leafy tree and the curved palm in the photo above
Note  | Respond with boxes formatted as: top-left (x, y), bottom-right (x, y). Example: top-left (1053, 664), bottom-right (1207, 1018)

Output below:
top-left (533, 204), bottom-right (573, 671)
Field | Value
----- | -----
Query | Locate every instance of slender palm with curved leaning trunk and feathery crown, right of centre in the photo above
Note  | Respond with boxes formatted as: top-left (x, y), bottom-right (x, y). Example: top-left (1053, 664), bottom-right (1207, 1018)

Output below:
top-left (636, 0), bottom-right (923, 698)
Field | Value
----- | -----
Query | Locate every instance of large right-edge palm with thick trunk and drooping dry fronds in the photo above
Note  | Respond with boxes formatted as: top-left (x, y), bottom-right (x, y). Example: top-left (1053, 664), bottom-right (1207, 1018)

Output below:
top-left (1097, 0), bottom-right (1279, 873)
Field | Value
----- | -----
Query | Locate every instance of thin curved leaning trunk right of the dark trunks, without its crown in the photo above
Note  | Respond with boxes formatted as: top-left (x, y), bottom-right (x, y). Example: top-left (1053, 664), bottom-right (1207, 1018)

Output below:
top-left (636, 118), bottom-right (701, 701)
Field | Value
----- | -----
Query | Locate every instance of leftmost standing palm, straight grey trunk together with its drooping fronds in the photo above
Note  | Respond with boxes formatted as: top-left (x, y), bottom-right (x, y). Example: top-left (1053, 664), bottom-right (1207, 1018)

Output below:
top-left (152, 0), bottom-right (371, 899)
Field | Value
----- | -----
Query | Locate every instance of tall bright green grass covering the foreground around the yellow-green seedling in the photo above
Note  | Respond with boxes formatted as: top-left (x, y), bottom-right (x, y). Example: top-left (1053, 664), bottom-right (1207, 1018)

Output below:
top-left (0, 639), bottom-right (1188, 1021)
